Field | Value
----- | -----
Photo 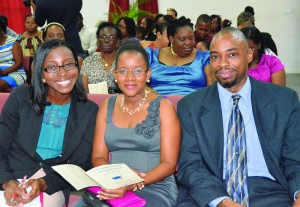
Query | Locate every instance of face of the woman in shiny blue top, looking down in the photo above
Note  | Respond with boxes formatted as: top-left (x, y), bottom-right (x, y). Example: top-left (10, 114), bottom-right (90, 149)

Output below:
top-left (170, 26), bottom-right (195, 57)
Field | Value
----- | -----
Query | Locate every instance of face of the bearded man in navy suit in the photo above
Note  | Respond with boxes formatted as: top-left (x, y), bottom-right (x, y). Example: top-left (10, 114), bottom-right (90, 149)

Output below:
top-left (210, 33), bottom-right (252, 93)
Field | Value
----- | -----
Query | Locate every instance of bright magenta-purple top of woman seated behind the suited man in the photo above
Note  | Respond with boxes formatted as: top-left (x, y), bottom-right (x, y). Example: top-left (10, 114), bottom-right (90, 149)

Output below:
top-left (248, 54), bottom-right (284, 83)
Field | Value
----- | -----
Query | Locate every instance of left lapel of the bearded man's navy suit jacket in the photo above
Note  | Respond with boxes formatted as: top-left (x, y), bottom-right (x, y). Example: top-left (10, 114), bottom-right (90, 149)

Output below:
top-left (196, 84), bottom-right (224, 178)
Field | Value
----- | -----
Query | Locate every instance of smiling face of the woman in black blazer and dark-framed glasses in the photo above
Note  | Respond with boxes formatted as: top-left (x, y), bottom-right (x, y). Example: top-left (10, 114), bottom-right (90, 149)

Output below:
top-left (42, 46), bottom-right (78, 100)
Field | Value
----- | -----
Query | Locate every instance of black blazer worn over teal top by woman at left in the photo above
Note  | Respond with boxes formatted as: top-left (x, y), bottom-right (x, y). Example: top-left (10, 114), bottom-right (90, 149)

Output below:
top-left (0, 87), bottom-right (98, 197)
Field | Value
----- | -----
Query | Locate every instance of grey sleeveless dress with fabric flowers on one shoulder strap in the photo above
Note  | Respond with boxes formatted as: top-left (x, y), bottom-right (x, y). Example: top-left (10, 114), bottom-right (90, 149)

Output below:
top-left (105, 96), bottom-right (178, 207)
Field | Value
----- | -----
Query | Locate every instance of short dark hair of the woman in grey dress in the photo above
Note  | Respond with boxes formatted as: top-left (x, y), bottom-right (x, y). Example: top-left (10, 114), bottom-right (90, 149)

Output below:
top-left (115, 40), bottom-right (150, 70)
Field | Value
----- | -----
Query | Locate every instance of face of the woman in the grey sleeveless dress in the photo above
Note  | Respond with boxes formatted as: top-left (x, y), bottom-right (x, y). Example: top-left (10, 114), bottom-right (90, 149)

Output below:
top-left (115, 51), bottom-right (151, 97)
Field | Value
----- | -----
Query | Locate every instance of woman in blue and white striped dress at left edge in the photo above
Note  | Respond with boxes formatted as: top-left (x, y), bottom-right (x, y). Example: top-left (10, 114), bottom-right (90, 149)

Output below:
top-left (0, 18), bottom-right (26, 92)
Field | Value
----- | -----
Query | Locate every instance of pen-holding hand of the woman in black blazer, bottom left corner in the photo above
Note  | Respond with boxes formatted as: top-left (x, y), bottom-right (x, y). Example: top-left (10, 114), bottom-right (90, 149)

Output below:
top-left (4, 180), bottom-right (27, 206)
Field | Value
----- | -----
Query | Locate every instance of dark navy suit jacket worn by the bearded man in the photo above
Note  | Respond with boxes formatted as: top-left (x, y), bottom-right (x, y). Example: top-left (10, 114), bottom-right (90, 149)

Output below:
top-left (177, 78), bottom-right (300, 206)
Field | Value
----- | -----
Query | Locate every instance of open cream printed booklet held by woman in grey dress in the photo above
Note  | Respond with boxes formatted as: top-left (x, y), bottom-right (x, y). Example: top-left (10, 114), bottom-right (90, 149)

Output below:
top-left (52, 163), bottom-right (144, 190)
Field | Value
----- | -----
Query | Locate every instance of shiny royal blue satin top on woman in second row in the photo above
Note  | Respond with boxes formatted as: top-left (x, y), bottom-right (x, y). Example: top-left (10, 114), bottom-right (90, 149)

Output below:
top-left (146, 48), bottom-right (209, 95)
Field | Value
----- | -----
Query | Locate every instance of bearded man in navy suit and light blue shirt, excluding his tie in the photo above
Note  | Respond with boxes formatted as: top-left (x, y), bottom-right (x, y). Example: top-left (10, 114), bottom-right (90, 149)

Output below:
top-left (178, 28), bottom-right (300, 207)
